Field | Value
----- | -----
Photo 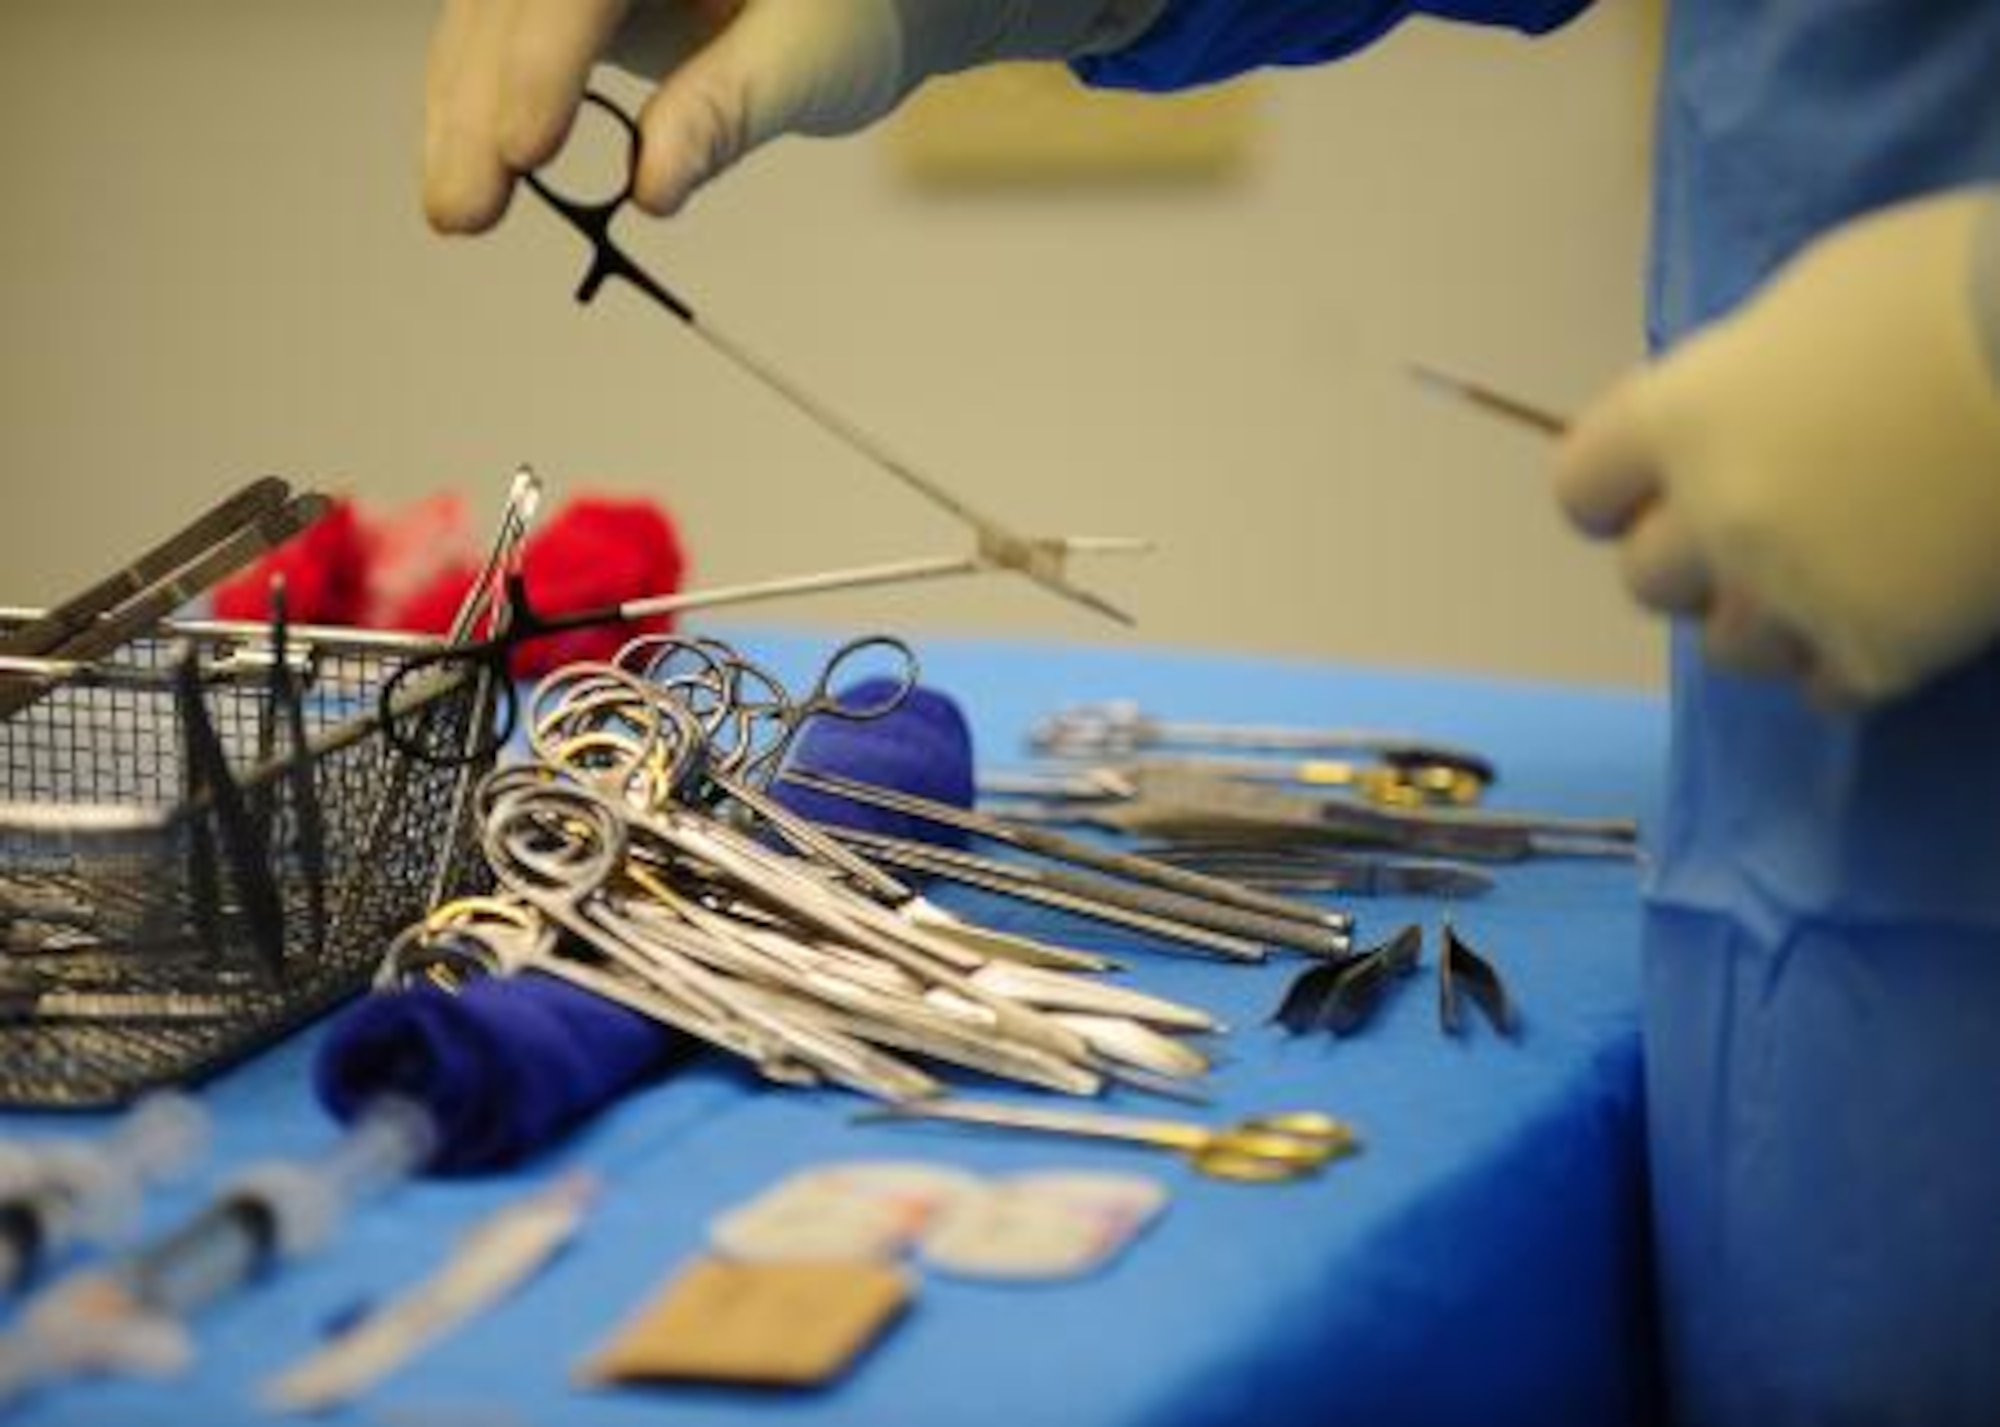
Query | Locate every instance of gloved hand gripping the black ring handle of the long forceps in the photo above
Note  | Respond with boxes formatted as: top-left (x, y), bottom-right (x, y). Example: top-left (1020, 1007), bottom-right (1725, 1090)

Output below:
top-left (424, 0), bottom-right (1166, 232)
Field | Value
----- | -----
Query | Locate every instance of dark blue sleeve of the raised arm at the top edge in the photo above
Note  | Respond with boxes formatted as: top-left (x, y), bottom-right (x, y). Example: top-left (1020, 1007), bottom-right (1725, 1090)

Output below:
top-left (1074, 0), bottom-right (1590, 90)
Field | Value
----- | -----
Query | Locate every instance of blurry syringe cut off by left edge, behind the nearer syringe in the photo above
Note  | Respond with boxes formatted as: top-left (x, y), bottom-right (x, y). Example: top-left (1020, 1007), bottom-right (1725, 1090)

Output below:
top-left (0, 1091), bottom-right (208, 1297)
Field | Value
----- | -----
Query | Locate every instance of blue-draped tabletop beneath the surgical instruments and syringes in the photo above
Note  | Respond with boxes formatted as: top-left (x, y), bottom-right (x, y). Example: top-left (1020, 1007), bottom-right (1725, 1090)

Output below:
top-left (0, 628), bottom-right (1664, 1427)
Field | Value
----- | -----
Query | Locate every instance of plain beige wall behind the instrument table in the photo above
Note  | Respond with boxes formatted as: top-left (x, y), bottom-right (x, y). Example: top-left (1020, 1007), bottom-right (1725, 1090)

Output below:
top-left (0, 0), bottom-right (1660, 682)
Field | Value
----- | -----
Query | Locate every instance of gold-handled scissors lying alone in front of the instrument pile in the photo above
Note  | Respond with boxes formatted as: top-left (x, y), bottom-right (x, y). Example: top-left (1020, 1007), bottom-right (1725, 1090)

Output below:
top-left (854, 1099), bottom-right (1360, 1183)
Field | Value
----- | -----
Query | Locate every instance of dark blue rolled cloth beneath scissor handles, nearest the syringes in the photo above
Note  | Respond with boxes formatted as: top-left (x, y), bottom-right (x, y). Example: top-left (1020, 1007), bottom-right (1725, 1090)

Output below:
top-left (314, 971), bottom-right (694, 1173)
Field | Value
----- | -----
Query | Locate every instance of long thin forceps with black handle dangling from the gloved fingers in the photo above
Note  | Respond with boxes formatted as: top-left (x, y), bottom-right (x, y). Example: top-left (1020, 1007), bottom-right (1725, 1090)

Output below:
top-left (526, 92), bottom-right (1152, 624)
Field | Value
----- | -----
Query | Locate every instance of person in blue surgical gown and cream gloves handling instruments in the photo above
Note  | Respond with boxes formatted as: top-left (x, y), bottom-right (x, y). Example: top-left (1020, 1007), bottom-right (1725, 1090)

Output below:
top-left (424, 0), bottom-right (2000, 1427)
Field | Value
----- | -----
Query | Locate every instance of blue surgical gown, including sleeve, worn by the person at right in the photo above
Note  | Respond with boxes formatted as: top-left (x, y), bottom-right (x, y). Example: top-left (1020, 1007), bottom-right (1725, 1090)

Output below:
top-left (1078, 0), bottom-right (2000, 1427)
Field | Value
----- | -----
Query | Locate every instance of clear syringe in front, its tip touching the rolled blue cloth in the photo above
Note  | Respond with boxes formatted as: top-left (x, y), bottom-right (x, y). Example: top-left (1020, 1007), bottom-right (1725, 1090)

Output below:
top-left (0, 1099), bottom-right (434, 1407)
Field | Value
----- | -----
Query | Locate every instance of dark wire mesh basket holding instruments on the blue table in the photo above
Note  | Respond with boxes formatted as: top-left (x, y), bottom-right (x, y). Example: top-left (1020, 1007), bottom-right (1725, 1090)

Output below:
top-left (0, 612), bottom-right (492, 1107)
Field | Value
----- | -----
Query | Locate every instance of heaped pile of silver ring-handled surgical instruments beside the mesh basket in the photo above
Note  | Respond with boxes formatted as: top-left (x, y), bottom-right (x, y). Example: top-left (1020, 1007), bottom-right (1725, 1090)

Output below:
top-left (384, 636), bottom-right (1346, 1101)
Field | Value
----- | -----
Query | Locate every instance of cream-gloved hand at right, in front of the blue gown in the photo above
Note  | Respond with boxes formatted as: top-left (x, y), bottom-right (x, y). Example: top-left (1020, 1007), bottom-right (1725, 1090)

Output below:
top-left (1556, 190), bottom-right (2000, 706)
